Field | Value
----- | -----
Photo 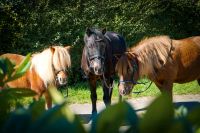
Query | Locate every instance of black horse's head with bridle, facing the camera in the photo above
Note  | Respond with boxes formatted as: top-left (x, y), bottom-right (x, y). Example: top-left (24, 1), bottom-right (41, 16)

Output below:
top-left (84, 28), bottom-right (108, 75)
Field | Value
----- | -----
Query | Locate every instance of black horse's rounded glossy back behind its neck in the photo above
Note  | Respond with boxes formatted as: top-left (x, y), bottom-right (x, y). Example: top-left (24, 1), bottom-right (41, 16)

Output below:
top-left (105, 31), bottom-right (126, 55)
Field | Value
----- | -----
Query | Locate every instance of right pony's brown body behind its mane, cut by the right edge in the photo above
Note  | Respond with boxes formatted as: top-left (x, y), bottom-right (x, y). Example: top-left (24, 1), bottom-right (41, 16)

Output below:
top-left (174, 36), bottom-right (200, 83)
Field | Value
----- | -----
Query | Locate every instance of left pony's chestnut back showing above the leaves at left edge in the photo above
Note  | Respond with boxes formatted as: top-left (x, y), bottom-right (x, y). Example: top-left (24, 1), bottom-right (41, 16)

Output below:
top-left (0, 53), bottom-right (25, 65)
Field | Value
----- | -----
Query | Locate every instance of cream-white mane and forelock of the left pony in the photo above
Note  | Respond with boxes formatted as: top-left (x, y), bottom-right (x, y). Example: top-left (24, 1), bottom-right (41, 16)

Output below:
top-left (31, 46), bottom-right (71, 87)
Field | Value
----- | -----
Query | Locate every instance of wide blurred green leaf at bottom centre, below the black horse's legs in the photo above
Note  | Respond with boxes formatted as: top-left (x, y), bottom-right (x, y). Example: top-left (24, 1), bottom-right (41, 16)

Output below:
top-left (90, 102), bottom-right (138, 133)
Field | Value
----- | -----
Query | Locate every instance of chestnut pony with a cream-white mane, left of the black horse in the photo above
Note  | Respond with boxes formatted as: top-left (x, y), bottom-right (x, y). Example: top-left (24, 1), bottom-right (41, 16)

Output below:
top-left (0, 46), bottom-right (71, 108)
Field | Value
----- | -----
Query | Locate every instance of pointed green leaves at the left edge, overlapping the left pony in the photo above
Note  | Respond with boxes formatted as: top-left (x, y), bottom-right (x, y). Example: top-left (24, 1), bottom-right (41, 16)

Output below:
top-left (0, 54), bottom-right (35, 127)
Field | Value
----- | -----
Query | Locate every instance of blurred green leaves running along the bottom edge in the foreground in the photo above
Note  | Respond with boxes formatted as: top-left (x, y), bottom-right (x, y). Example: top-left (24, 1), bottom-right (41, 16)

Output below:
top-left (0, 88), bottom-right (200, 133)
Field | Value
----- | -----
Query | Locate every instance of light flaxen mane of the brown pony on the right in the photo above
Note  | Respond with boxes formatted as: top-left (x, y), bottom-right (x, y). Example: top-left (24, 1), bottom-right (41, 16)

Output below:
top-left (117, 36), bottom-right (172, 76)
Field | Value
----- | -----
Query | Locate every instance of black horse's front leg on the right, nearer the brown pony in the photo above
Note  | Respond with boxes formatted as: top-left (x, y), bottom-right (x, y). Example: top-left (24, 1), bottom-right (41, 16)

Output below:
top-left (103, 78), bottom-right (113, 106)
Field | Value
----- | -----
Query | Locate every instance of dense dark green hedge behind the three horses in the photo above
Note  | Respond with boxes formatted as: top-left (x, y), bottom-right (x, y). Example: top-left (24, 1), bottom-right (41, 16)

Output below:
top-left (0, 0), bottom-right (200, 82)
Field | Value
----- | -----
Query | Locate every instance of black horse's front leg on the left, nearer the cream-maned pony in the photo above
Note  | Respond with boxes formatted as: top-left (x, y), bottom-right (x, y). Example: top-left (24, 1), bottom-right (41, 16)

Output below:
top-left (89, 78), bottom-right (97, 116)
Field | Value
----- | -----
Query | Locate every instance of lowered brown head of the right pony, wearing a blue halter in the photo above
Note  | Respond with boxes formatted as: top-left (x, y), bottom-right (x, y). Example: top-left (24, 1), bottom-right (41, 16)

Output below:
top-left (115, 53), bottom-right (139, 95)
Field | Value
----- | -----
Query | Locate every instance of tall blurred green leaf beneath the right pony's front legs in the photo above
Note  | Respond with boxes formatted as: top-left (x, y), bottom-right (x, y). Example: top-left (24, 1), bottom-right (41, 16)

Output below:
top-left (139, 94), bottom-right (174, 133)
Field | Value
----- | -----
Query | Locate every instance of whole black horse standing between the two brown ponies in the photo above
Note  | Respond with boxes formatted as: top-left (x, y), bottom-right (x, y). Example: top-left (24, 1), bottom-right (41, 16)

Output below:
top-left (81, 28), bottom-right (126, 115)
